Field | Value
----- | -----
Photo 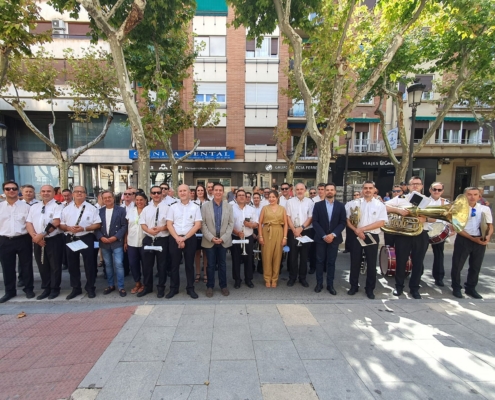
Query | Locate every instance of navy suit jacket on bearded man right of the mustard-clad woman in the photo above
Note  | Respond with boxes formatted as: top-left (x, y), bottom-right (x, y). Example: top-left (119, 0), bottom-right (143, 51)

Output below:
top-left (313, 200), bottom-right (347, 244)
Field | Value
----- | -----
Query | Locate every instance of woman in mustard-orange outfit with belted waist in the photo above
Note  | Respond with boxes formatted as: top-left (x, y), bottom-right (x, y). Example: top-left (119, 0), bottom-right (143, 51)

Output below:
top-left (258, 190), bottom-right (287, 287)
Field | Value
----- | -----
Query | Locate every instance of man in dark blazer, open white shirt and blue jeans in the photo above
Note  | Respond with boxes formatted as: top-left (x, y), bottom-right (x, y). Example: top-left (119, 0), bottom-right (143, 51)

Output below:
top-left (95, 191), bottom-right (128, 297)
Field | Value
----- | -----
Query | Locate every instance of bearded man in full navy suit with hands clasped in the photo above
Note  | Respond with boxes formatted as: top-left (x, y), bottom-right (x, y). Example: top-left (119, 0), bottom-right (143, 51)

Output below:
top-left (313, 183), bottom-right (346, 296)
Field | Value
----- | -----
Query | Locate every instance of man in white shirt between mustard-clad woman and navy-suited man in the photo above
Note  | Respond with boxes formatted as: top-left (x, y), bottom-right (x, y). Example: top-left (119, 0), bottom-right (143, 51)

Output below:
top-left (282, 183), bottom-right (315, 287)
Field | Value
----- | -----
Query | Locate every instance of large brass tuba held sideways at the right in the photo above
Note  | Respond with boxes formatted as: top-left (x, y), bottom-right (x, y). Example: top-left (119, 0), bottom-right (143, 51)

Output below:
top-left (382, 194), bottom-right (469, 236)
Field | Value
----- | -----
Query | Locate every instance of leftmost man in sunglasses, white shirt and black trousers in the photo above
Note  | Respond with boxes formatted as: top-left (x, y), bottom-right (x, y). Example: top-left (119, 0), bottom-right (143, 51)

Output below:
top-left (0, 181), bottom-right (35, 303)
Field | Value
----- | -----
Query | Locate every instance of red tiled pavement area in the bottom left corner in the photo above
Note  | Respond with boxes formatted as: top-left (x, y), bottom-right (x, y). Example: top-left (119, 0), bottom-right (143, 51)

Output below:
top-left (0, 306), bottom-right (136, 400)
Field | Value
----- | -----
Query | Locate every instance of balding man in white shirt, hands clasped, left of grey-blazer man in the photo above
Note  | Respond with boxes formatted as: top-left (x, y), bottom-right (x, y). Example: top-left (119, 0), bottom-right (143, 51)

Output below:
top-left (166, 185), bottom-right (203, 299)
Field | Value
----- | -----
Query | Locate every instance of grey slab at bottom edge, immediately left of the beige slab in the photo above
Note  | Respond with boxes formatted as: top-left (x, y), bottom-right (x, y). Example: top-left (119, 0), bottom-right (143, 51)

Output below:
top-left (208, 360), bottom-right (263, 400)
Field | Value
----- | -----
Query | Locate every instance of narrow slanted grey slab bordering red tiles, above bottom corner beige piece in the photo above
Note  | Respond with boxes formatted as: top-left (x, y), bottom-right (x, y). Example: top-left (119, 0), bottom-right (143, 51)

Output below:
top-left (79, 341), bottom-right (129, 388)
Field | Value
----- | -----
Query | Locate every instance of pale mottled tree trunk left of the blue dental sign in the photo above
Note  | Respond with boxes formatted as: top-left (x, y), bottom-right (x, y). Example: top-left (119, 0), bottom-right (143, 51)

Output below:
top-left (108, 34), bottom-right (150, 193)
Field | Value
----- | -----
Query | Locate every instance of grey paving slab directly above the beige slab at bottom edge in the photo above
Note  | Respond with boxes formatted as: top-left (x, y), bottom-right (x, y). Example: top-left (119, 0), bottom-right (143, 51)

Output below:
top-left (253, 340), bottom-right (309, 383)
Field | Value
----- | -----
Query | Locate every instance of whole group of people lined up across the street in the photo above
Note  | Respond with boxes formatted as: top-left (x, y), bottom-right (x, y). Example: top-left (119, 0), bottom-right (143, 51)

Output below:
top-left (0, 177), bottom-right (493, 303)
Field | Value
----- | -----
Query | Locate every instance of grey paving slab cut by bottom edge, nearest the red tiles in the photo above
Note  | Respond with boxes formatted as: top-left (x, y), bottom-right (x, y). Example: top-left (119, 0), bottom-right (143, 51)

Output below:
top-left (97, 361), bottom-right (163, 400)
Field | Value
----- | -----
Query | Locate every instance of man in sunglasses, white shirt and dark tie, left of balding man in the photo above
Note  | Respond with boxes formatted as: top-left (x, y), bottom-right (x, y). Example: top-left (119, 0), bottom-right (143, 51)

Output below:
top-left (137, 186), bottom-right (170, 299)
